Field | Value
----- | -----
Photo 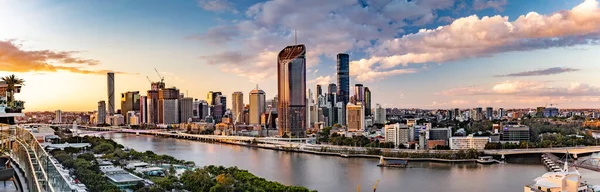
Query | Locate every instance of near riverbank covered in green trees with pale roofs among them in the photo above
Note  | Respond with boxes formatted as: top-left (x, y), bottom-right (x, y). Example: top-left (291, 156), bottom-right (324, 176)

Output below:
top-left (51, 136), bottom-right (313, 192)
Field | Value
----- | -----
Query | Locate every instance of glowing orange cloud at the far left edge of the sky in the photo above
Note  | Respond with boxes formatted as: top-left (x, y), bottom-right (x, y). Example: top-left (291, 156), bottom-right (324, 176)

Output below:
top-left (0, 40), bottom-right (120, 74)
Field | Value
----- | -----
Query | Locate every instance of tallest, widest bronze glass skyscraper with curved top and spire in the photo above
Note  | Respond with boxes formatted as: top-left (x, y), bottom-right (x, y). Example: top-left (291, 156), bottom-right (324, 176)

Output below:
top-left (277, 45), bottom-right (306, 137)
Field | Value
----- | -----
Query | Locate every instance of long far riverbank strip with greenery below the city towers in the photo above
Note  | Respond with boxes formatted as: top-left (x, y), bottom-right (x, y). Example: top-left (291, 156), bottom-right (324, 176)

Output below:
top-left (121, 132), bottom-right (481, 163)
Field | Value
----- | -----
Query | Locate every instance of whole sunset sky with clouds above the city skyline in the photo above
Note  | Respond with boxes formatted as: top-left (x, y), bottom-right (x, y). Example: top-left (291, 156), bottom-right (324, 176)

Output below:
top-left (0, 0), bottom-right (600, 111)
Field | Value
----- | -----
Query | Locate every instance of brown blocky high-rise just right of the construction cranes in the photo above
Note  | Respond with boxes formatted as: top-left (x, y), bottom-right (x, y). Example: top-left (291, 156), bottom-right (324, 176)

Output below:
top-left (158, 87), bottom-right (179, 124)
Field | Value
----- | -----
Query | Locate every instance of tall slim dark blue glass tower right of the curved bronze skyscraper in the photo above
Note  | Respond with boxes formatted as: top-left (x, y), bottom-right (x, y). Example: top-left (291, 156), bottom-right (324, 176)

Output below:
top-left (337, 53), bottom-right (350, 105)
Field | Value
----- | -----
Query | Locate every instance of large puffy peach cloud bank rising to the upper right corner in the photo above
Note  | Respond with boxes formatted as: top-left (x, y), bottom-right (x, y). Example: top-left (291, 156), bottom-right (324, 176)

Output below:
top-left (358, 0), bottom-right (600, 80)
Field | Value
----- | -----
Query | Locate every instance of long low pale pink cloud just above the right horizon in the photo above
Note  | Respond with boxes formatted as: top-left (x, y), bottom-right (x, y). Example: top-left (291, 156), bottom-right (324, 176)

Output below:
top-left (440, 81), bottom-right (600, 97)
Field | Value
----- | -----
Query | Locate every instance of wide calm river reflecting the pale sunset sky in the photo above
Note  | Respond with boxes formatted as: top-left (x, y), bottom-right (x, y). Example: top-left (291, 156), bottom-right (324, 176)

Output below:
top-left (104, 133), bottom-right (600, 192)
